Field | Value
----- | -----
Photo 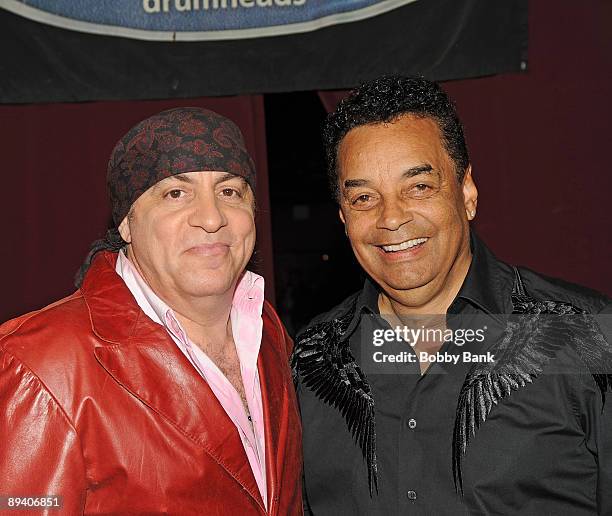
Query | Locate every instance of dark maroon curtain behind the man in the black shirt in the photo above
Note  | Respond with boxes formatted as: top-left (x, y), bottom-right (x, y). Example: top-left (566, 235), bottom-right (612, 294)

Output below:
top-left (320, 0), bottom-right (612, 295)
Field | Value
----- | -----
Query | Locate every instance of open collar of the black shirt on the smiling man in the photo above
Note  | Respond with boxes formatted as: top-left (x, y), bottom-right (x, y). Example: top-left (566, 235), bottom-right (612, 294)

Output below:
top-left (347, 230), bottom-right (514, 334)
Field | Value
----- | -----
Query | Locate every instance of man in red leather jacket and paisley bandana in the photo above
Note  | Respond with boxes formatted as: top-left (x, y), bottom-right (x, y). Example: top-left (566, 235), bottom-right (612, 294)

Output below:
top-left (0, 108), bottom-right (302, 516)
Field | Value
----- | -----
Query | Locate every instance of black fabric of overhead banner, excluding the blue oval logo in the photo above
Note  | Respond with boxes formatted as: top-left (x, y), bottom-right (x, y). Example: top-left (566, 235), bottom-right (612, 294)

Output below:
top-left (0, 0), bottom-right (527, 103)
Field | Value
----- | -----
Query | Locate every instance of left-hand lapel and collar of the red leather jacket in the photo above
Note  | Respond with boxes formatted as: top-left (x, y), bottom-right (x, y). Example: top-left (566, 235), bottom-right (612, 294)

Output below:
top-left (82, 252), bottom-right (264, 510)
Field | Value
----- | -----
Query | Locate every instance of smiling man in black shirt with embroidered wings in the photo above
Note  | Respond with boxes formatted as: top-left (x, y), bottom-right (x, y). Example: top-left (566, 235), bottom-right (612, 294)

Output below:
top-left (292, 77), bottom-right (612, 516)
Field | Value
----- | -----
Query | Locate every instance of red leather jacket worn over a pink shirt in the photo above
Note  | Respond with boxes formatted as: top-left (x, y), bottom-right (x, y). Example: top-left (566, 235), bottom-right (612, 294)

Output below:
top-left (0, 252), bottom-right (302, 516)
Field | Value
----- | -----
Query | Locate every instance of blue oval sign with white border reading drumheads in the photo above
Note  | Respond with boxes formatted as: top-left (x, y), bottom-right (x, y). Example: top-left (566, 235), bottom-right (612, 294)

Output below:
top-left (0, 0), bottom-right (416, 41)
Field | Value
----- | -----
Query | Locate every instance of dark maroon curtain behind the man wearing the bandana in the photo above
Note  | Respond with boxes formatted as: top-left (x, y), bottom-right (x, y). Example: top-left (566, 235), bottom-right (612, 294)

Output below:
top-left (0, 96), bottom-right (274, 321)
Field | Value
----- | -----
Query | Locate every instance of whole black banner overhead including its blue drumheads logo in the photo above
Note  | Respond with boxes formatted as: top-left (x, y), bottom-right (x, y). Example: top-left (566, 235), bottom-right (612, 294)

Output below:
top-left (0, 0), bottom-right (527, 103)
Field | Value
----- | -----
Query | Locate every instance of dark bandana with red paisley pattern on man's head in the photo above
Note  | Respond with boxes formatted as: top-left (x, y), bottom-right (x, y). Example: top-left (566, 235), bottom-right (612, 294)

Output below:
top-left (107, 107), bottom-right (255, 226)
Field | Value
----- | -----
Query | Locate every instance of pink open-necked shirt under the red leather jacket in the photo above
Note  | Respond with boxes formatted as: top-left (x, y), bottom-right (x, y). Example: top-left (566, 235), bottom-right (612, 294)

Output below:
top-left (115, 251), bottom-right (268, 507)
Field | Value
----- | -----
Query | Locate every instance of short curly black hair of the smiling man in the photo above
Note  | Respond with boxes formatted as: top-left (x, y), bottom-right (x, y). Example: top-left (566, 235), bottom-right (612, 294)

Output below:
top-left (323, 75), bottom-right (470, 200)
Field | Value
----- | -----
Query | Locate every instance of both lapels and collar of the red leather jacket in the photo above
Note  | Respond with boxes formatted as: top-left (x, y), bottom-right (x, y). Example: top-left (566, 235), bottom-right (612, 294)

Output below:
top-left (81, 251), bottom-right (290, 512)
